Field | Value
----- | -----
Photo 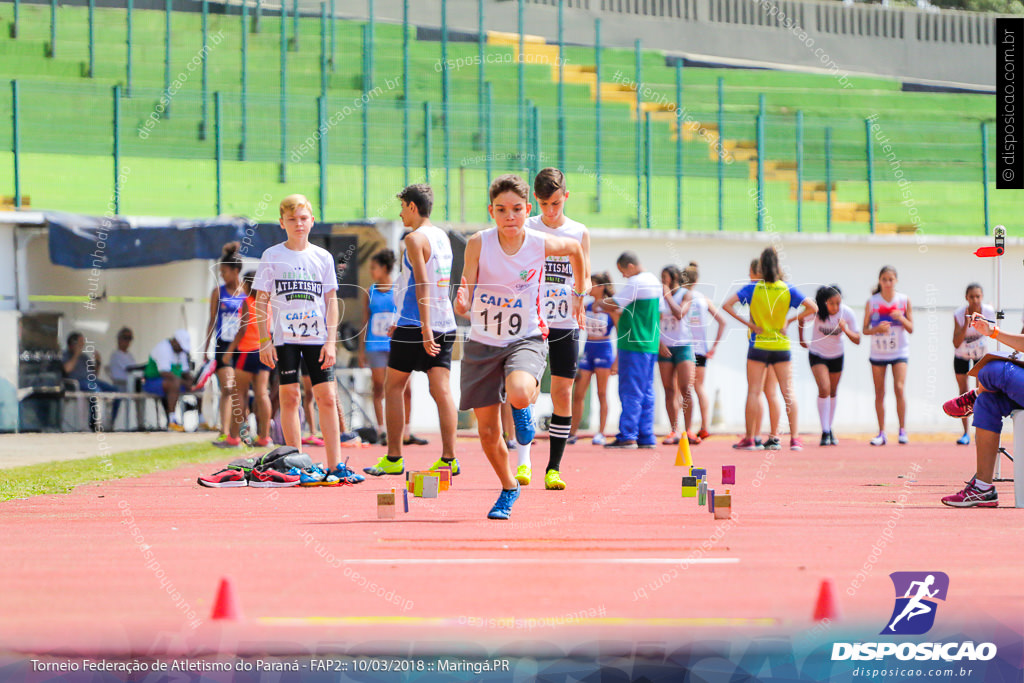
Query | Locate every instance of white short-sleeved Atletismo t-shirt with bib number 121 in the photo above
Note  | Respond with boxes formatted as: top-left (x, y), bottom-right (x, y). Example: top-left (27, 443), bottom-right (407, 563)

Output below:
top-left (253, 244), bottom-right (338, 346)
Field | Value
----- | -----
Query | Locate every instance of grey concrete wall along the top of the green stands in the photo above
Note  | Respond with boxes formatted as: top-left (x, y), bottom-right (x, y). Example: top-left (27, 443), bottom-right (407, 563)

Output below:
top-left (339, 0), bottom-right (995, 88)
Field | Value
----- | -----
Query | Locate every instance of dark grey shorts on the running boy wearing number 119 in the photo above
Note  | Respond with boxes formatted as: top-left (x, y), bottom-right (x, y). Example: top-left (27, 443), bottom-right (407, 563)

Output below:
top-left (459, 337), bottom-right (548, 411)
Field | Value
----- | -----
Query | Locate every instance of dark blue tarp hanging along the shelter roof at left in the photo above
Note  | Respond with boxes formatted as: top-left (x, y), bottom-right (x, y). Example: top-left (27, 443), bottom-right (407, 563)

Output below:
top-left (44, 211), bottom-right (330, 269)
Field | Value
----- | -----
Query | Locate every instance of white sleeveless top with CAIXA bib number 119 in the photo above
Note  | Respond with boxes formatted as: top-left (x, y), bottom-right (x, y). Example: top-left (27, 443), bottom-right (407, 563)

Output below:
top-left (469, 227), bottom-right (547, 346)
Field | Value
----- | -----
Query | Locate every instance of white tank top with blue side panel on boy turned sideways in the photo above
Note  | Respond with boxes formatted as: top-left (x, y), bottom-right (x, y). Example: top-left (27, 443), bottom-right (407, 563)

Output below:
top-left (395, 225), bottom-right (456, 332)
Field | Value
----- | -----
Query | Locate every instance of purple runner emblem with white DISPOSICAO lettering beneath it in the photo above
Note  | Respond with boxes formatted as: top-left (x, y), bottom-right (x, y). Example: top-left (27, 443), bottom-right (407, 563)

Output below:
top-left (831, 571), bottom-right (996, 661)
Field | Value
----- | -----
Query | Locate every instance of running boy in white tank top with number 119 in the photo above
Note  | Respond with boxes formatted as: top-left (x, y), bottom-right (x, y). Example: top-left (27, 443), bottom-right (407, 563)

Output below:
top-left (455, 175), bottom-right (590, 519)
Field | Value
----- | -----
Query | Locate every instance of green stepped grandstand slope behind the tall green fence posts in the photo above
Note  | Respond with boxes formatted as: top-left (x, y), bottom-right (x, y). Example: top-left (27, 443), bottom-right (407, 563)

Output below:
top-left (0, 2), bottom-right (999, 233)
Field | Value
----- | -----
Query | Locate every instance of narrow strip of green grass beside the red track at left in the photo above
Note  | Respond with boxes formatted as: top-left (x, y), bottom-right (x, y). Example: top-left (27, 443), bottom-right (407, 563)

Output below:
top-left (0, 443), bottom-right (223, 502)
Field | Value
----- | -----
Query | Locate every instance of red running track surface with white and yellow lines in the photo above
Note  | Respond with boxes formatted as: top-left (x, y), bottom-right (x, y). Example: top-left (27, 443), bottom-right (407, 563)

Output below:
top-left (0, 436), bottom-right (1024, 656)
